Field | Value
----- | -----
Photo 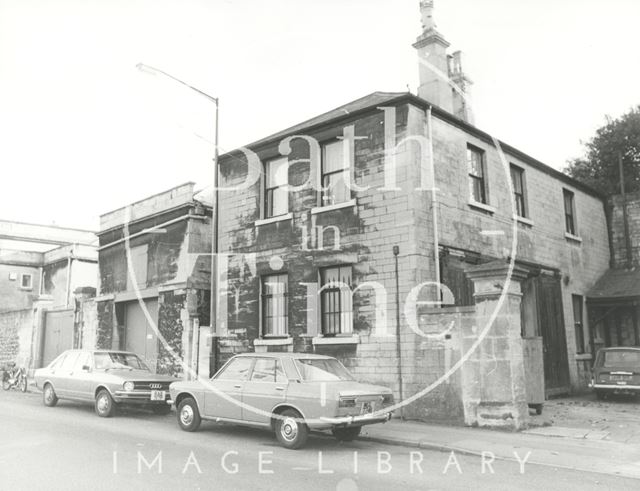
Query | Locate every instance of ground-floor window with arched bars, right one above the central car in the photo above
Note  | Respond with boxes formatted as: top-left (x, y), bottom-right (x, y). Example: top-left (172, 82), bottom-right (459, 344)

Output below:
top-left (320, 266), bottom-right (353, 336)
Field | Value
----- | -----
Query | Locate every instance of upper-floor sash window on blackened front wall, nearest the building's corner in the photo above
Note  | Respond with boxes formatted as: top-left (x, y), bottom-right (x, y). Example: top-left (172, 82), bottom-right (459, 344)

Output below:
top-left (320, 140), bottom-right (351, 206)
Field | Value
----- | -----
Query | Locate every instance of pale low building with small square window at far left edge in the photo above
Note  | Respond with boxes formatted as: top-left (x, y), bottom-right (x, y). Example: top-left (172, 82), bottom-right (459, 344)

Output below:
top-left (0, 220), bottom-right (98, 369)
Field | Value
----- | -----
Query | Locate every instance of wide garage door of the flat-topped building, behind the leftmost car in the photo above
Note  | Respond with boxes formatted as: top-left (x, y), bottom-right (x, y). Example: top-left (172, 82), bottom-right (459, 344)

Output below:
top-left (124, 298), bottom-right (158, 372)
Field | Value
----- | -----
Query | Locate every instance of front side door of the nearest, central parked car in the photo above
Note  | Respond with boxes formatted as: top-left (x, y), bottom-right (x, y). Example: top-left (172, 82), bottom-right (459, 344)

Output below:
top-left (204, 357), bottom-right (253, 420)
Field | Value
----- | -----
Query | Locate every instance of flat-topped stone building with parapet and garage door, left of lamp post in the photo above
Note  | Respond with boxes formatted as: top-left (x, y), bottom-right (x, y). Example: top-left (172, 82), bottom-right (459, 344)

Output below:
top-left (93, 183), bottom-right (211, 375)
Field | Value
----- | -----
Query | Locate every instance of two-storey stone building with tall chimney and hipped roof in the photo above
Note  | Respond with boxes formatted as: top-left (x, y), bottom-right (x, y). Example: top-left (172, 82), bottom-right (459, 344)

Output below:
top-left (209, 2), bottom-right (609, 427)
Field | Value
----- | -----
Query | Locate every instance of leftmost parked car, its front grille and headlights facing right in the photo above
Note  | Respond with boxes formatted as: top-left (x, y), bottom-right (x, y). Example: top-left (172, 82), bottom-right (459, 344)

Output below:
top-left (34, 350), bottom-right (175, 418)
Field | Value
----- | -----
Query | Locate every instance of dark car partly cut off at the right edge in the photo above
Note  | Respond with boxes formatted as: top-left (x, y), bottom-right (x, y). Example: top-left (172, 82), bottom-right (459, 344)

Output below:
top-left (589, 347), bottom-right (640, 399)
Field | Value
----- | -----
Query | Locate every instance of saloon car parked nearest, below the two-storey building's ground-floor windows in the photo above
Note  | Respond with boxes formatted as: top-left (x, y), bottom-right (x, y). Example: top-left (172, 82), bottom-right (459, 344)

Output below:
top-left (170, 353), bottom-right (393, 449)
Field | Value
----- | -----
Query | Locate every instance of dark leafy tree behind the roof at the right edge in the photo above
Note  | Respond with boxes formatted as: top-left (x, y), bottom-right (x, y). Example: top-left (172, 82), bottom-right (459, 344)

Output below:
top-left (565, 106), bottom-right (640, 195)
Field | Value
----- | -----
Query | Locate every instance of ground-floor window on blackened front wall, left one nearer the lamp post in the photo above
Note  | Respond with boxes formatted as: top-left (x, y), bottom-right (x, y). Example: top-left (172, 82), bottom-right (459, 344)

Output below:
top-left (262, 274), bottom-right (289, 336)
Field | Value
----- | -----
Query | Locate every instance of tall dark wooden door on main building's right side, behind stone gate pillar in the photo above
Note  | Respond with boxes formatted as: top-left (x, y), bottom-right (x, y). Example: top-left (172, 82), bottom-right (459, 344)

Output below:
top-left (536, 273), bottom-right (569, 396)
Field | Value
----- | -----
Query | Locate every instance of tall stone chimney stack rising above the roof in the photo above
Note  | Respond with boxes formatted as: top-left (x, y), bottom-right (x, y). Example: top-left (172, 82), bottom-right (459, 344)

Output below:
top-left (413, 0), bottom-right (473, 124)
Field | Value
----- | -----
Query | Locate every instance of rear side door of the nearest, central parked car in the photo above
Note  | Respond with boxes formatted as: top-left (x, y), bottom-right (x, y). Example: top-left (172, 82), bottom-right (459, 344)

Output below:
top-left (242, 358), bottom-right (287, 424)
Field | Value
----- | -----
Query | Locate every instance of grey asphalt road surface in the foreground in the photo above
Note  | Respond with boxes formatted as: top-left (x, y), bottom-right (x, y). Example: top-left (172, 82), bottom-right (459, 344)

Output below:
top-left (0, 391), bottom-right (640, 491)
